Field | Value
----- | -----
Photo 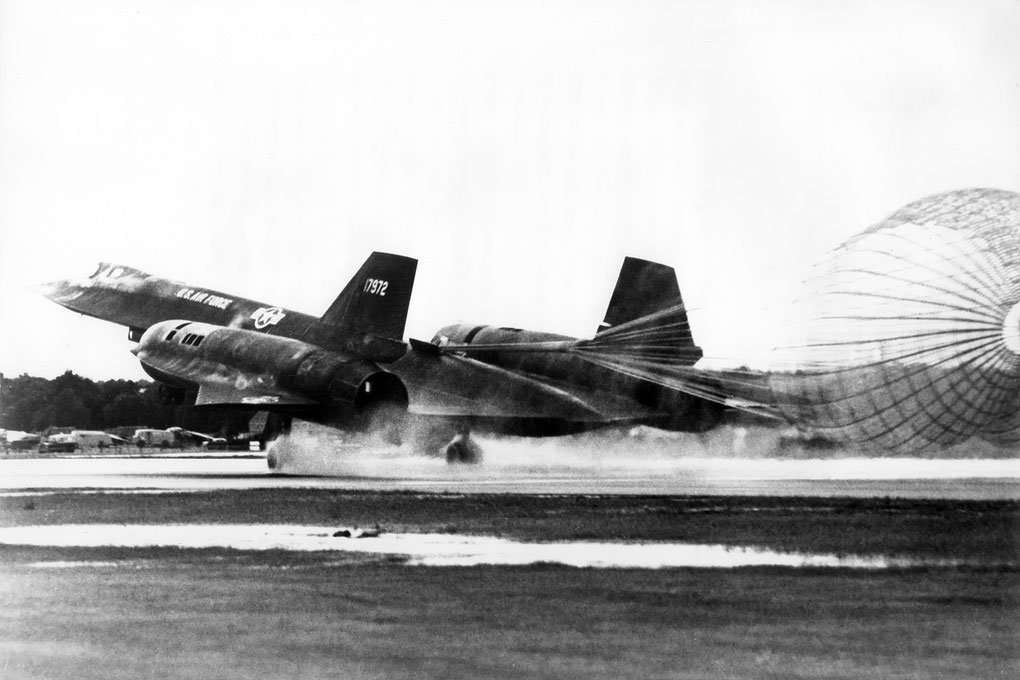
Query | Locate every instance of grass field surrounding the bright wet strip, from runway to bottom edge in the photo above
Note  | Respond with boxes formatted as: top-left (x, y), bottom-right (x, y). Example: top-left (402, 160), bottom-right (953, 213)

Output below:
top-left (0, 489), bottom-right (1020, 679)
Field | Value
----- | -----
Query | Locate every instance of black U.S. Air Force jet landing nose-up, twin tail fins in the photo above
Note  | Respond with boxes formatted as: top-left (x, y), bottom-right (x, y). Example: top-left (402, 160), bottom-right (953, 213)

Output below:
top-left (39, 253), bottom-right (722, 462)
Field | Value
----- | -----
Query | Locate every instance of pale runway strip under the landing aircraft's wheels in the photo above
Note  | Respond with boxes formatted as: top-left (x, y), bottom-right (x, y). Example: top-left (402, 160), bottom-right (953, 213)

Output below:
top-left (0, 455), bottom-right (1020, 500)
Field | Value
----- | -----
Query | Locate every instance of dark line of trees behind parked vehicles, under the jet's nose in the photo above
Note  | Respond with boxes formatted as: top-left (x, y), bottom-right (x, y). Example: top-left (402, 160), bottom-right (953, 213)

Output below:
top-left (0, 371), bottom-right (225, 432)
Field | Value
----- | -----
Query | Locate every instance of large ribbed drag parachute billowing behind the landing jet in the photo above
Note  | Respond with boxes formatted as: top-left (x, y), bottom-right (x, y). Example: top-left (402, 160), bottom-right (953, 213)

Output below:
top-left (769, 189), bottom-right (1020, 454)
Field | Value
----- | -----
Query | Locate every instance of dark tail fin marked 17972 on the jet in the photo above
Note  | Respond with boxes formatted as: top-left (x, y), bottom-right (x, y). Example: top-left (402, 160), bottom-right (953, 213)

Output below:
top-left (319, 253), bottom-right (418, 339)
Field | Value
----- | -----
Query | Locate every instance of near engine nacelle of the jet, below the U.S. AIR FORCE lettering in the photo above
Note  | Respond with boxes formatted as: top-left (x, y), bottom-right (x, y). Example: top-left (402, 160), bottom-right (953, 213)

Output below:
top-left (135, 320), bottom-right (407, 408)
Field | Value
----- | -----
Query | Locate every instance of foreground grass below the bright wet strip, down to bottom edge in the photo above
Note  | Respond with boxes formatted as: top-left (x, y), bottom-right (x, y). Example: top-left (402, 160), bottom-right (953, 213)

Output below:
top-left (0, 552), bottom-right (1018, 678)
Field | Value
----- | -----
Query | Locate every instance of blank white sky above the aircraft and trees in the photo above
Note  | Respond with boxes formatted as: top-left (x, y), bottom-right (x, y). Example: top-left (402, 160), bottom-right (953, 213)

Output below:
top-left (0, 0), bottom-right (1020, 379)
